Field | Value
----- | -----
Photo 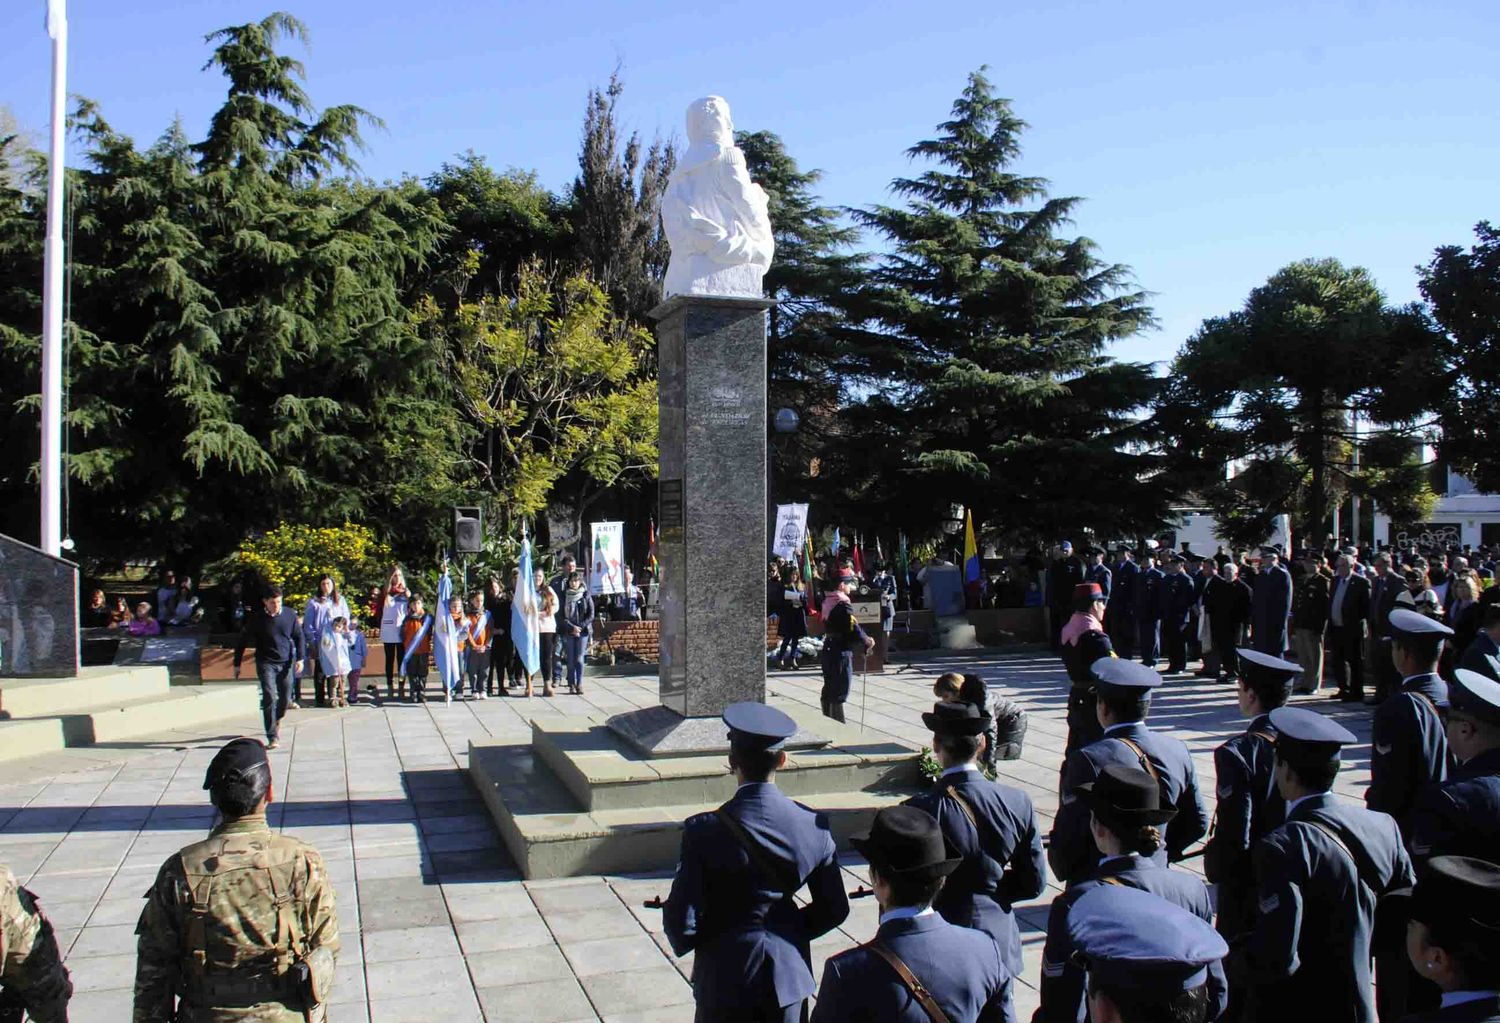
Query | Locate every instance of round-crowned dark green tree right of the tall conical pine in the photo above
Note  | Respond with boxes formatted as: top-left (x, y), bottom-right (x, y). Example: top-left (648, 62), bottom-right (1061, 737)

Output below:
top-left (1161, 260), bottom-right (1437, 543)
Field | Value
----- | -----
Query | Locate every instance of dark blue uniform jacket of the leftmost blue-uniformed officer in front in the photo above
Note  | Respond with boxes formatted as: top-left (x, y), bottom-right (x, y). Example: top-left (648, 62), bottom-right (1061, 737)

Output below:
top-left (663, 783), bottom-right (849, 1019)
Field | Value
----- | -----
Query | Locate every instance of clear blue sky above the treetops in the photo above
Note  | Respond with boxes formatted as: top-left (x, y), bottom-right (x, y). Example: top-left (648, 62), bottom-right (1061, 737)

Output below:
top-left (0, 0), bottom-right (1500, 360)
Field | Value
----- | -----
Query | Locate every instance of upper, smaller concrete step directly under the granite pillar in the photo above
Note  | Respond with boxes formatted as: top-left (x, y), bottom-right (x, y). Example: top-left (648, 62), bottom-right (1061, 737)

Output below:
top-left (531, 708), bottom-right (918, 813)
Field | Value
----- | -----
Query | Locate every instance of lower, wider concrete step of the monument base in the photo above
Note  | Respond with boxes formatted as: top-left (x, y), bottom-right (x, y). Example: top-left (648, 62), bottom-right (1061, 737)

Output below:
top-left (468, 741), bottom-right (918, 879)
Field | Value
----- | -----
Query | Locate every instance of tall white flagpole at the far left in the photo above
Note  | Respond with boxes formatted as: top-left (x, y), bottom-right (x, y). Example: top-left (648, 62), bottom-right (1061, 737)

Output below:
top-left (42, 0), bottom-right (68, 557)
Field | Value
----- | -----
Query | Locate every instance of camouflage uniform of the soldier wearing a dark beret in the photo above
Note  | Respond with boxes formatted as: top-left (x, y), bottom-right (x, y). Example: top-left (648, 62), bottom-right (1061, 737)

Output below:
top-left (134, 813), bottom-right (339, 1023)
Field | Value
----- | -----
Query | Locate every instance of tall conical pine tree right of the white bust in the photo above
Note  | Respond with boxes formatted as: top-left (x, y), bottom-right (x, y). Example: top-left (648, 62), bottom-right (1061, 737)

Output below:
top-left (834, 69), bottom-right (1167, 536)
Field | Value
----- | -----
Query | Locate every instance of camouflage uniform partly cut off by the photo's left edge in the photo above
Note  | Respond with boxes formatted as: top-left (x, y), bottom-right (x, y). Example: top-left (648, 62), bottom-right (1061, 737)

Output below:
top-left (0, 866), bottom-right (74, 1023)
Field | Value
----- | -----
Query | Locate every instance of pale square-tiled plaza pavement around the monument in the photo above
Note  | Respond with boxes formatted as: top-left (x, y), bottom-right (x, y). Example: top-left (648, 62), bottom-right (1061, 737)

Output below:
top-left (0, 654), bottom-right (1370, 1023)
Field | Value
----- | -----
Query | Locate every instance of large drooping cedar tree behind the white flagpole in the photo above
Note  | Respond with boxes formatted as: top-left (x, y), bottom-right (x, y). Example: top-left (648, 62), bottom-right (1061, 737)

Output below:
top-left (0, 15), bottom-right (461, 564)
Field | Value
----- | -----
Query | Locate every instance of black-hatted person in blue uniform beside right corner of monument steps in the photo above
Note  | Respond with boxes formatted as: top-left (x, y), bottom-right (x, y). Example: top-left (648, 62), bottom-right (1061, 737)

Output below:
top-left (908, 696), bottom-right (1044, 1016)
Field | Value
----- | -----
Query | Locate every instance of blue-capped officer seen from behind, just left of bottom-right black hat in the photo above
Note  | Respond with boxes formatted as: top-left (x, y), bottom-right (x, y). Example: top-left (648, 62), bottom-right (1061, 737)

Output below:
top-left (1230, 707), bottom-right (1413, 1023)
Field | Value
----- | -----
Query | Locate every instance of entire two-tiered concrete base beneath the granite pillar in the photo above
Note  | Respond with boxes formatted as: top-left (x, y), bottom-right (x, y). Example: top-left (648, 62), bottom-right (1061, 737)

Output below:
top-left (468, 699), bottom-right (923, 879)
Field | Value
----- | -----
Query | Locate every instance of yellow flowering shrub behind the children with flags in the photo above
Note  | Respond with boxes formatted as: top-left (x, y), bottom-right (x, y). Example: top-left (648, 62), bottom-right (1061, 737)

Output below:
top-left (230, 522), bottom-right (392, 608)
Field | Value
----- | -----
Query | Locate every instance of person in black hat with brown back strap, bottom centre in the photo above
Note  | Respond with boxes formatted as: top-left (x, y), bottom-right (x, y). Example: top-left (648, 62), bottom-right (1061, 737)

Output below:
top-left (816, 806), bottom-right (1011, 1023)
